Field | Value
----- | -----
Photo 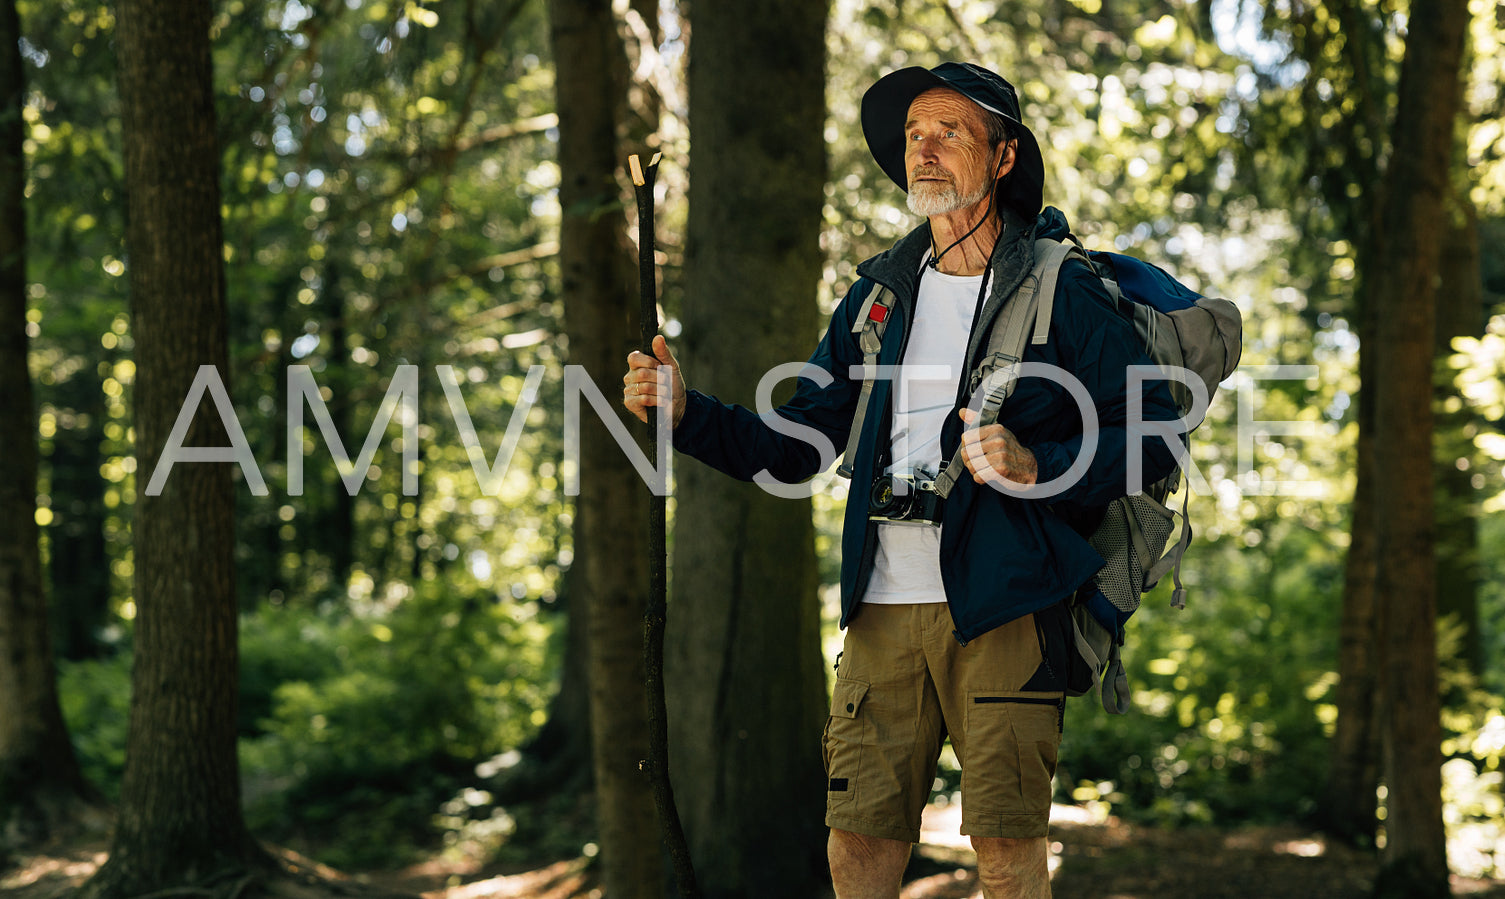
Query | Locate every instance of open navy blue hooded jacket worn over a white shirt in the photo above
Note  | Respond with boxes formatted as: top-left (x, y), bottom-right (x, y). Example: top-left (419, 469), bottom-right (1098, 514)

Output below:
top-left (674, 208), bottom-right (1178, 643)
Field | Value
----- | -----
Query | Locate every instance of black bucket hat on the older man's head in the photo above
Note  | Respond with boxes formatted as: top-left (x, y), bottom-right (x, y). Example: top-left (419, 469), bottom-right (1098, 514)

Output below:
top-left (862, 62), bottom-right (1044, 215)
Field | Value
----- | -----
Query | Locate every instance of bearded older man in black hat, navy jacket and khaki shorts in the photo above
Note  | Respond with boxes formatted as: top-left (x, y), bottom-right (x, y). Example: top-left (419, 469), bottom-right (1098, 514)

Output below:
top-left (623, 63), bottom-right (1177, 899)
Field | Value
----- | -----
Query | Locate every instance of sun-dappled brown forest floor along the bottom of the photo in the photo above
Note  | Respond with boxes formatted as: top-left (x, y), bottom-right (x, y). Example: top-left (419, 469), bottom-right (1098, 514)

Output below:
top-left (0, 807), bottom-right (1505, 899)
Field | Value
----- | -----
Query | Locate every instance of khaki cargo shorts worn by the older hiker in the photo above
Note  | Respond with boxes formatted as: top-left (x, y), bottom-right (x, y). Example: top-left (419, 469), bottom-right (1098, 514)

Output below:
top-left (823, 602), bottom-right (1066, 843)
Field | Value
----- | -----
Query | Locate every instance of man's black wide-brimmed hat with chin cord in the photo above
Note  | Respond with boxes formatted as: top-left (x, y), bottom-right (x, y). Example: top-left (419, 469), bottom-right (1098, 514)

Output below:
top-left (862, 66), bottom-right (1044, 214)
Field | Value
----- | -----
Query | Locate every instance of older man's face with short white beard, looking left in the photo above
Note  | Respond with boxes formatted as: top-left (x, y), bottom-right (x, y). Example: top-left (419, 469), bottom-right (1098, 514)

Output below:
top-left (905, 87), bottom-right (1011, 215)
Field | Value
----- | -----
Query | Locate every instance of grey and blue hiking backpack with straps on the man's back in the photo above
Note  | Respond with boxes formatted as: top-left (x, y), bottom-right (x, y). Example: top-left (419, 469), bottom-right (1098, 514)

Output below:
top-left (840, 236), bottom-right (1243, 715)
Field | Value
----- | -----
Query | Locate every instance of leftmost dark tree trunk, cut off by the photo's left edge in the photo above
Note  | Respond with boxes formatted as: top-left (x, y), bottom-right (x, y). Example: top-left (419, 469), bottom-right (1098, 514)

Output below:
top-left (0, 0), bottom-right (96, 849)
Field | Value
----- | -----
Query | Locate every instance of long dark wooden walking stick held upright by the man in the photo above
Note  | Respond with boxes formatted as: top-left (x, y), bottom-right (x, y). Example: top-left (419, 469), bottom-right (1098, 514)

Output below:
top-left (628, 154), bottom-right (700, 899)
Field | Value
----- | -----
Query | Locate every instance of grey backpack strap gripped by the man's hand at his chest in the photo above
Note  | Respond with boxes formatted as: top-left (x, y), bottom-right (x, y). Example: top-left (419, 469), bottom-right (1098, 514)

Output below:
top-left (935, 239), bottom-right (1087, 497)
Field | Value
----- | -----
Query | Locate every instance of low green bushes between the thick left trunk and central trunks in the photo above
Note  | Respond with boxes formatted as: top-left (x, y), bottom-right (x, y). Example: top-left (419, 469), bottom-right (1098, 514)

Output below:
top-left (242, 587), bottom-right (558, 867)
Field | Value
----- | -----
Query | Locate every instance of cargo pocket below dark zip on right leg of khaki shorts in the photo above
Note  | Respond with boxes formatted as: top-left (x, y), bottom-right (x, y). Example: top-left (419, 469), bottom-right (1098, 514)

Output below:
top-left (962, 691), bottom-right (1066, 818)
